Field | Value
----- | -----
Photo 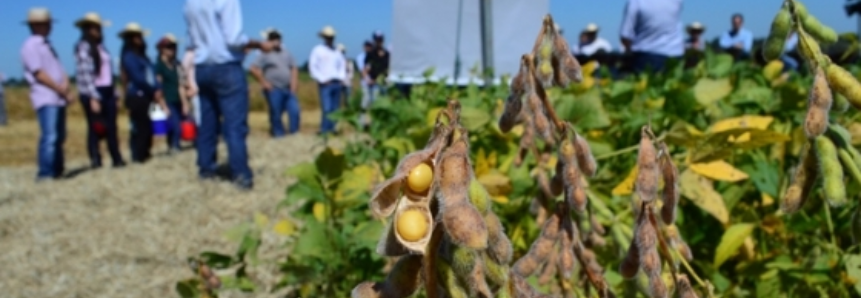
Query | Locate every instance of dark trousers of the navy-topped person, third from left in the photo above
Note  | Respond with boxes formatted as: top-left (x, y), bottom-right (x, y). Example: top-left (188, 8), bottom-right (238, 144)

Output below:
top-left (126, 95), bottom-right (153, 162)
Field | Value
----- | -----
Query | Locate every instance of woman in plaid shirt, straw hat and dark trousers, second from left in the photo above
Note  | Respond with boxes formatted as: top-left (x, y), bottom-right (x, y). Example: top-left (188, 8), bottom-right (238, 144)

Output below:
top-left (75, 12), bottom-right (125, 168)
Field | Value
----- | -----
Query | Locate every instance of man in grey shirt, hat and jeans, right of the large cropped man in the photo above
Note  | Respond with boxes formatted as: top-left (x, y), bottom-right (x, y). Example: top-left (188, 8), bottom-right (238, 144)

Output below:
top-left (250, 28), bottom-right (301, 138)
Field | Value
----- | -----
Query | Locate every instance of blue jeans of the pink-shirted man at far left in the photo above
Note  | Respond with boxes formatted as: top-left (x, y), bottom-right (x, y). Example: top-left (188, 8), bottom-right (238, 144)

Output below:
top-left (36, 106), bottom-right (66, 179)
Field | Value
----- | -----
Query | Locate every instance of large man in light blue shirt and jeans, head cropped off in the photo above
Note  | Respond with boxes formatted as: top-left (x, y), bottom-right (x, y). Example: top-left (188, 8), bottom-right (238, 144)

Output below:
top-left (184, 0), bottom-right (272, 190)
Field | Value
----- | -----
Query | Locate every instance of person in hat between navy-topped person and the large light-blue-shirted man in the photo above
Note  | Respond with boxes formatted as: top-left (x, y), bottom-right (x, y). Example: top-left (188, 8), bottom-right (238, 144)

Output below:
top-left (155, 33), bottom-right (190, 153)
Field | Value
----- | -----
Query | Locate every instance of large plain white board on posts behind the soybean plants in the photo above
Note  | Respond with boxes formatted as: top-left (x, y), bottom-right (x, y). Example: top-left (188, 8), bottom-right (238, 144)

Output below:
top-left (389, 0), bottom-right (549, 85)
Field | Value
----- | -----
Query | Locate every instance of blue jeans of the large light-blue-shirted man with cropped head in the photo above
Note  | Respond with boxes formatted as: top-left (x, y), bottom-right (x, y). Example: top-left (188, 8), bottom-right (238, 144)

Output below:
top-left (195, 62), bottom-right (253, 182)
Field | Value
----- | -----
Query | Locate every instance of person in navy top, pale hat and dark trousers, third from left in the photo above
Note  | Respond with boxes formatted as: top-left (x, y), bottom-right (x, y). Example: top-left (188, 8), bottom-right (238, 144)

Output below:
top-left (119, 23), bottom-right (162, 163)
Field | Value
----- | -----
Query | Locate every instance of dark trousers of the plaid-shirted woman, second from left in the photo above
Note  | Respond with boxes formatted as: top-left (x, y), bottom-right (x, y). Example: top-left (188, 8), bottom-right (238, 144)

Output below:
top-left (81, 87), bottom-right (123, 165)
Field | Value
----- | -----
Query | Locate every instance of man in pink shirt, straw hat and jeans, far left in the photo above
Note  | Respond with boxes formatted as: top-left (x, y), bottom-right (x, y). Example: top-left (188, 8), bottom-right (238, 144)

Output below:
top-left (21, 7), bottom-right (72, 181)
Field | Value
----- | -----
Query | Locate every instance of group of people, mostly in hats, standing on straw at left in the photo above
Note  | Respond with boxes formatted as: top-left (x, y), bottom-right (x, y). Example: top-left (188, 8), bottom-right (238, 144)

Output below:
top-left (21, 0), bottom-right (389, 190)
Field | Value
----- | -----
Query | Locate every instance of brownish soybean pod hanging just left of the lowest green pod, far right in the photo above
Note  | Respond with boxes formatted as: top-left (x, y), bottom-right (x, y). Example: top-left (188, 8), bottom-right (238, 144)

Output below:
top-left (780, 144), bottom-right (819, 213)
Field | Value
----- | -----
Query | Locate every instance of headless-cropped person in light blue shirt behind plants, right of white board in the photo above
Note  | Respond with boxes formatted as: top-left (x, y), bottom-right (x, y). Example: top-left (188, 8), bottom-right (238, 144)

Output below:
top-left (620, 0), bottom-right (685, 73)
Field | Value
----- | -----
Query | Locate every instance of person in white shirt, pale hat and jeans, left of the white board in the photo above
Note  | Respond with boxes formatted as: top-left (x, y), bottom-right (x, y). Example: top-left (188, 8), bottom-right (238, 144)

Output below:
top-left (308, 26), bottom-right (347, 134)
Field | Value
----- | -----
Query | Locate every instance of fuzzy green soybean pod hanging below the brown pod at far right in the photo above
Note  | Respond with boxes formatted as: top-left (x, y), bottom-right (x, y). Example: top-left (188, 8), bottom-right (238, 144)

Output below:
top-left (816, 136), bottom-right (847, 207)
